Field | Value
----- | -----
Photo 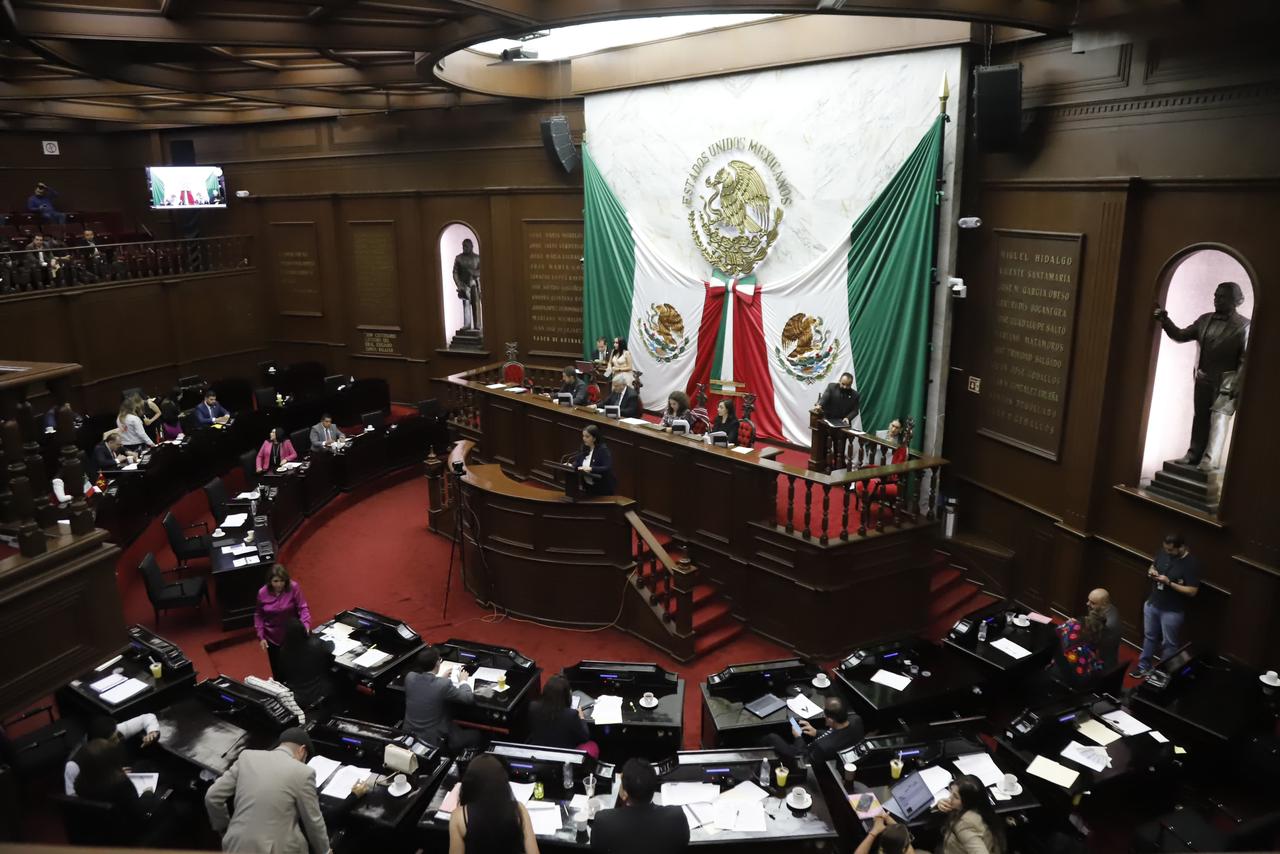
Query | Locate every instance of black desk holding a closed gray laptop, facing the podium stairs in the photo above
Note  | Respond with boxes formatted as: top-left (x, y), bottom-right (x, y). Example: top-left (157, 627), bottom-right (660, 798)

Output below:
top-left (701, 658), bottom-right (852, 748)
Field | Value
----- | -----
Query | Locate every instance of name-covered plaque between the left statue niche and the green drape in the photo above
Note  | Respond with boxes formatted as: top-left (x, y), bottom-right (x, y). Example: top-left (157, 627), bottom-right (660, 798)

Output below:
top-left (525, 220), bottom-right (582, 359)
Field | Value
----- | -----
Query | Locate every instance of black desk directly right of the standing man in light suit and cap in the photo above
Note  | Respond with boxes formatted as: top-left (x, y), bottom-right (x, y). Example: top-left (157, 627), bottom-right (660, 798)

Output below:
top-left (308, 717), bottom-right (449, 834)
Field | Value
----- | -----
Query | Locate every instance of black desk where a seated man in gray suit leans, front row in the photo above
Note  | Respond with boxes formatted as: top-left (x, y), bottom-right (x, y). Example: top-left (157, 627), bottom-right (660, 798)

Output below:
top-left (387, 638), bottom-right (543, 739)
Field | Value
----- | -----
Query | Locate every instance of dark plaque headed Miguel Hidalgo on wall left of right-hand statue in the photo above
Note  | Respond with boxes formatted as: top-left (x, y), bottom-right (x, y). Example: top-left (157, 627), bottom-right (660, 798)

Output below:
top-left (978, 228), bottom-right (1083, 460)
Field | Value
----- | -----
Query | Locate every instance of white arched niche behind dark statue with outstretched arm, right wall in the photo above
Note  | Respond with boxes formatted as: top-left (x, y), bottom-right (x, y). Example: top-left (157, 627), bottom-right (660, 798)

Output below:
top-left (1142, 243), bottom-right (1254, 485)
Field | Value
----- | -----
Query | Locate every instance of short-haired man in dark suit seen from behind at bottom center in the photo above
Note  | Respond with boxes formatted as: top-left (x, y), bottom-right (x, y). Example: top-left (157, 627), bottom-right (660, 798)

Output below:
top-left (591, 759), bottom-right (689, 854)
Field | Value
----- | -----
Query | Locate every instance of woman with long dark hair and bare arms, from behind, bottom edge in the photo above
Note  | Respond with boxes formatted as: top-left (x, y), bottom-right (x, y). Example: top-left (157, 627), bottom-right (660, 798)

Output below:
top-left (449, 753), bottom-right (538, 854)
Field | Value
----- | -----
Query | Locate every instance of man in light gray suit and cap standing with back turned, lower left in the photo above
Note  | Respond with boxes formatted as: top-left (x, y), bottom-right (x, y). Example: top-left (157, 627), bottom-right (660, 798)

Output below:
top-left (205, 727), bottom-right (332, 854)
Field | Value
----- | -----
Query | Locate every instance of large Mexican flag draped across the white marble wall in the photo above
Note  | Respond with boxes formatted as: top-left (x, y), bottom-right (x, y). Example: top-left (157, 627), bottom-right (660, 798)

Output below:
top-left (582, 115), bottom-right (945, 446)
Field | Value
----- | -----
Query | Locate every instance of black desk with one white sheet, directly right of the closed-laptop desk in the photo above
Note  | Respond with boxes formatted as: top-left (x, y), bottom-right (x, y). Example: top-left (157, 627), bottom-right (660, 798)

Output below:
top-left (832, 636), bottom-right (988, 729)
